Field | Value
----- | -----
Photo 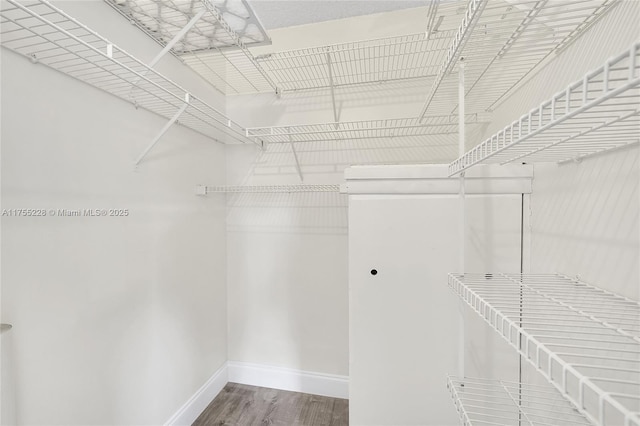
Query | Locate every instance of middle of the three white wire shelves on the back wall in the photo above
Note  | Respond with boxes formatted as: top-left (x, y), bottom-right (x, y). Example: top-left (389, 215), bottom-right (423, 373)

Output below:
top-left (247, 114), bottom-right (479, 143)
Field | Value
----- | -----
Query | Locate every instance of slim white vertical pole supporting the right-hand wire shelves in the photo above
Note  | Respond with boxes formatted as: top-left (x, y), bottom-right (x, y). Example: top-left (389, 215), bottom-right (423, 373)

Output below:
top-left (458, 58), bottom-right (466, 380)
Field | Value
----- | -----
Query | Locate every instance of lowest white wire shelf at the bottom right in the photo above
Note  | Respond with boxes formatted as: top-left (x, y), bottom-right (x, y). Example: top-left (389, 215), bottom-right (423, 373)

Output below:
top-left (447, 376), bottom-right (591, 426)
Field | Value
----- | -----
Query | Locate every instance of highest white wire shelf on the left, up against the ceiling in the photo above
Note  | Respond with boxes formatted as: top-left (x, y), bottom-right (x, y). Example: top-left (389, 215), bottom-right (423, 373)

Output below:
top-left (105, 0), bottom-right (276, 94)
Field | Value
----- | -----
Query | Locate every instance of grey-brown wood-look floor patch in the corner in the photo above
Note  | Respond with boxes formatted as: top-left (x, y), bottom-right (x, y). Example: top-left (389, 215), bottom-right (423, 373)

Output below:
top-left (193, 383), bottom-right (349, 426)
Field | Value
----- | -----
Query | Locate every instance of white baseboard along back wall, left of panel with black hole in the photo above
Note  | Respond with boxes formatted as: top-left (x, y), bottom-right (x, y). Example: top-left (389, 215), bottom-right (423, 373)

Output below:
top-left (227, 361), bottom-right (349, 398)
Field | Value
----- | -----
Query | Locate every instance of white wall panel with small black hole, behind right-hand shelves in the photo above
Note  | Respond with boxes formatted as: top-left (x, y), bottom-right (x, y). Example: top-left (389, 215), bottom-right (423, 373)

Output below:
top-left (347, 166), bottom-right (529, 426)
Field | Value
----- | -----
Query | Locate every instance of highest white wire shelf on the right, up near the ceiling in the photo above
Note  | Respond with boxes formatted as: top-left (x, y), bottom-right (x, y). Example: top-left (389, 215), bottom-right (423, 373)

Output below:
top-left (419, 0), bottom-right (619, 117)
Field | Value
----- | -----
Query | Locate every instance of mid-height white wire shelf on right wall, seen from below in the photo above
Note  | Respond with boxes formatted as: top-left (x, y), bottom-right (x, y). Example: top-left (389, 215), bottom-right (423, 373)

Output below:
top-left (449, 41), bottom-right (640, 175)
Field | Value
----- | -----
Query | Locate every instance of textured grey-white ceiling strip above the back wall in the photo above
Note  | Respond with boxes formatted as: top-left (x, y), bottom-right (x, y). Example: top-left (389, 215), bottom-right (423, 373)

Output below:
top-left (249, 0), bottom-right (430, 30)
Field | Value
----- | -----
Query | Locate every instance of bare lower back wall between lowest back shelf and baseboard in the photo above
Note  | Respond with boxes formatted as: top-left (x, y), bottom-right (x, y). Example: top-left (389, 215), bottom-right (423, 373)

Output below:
top-left (218, 147), bottom-right (348, 375)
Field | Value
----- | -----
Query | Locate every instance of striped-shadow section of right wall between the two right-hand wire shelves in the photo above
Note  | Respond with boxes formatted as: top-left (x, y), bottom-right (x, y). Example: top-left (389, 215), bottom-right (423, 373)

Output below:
top-left (532, 147), bottom-right (640, 300)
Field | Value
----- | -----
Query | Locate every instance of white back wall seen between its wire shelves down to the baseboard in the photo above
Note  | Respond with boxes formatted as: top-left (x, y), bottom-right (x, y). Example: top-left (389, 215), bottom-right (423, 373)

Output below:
top-left (221, 5), bottom-right (468, 375)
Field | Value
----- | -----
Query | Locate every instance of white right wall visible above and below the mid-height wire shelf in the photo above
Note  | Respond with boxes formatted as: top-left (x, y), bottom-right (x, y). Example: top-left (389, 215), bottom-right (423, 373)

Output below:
top-left (489, 1), bottom-right (640, 300)
